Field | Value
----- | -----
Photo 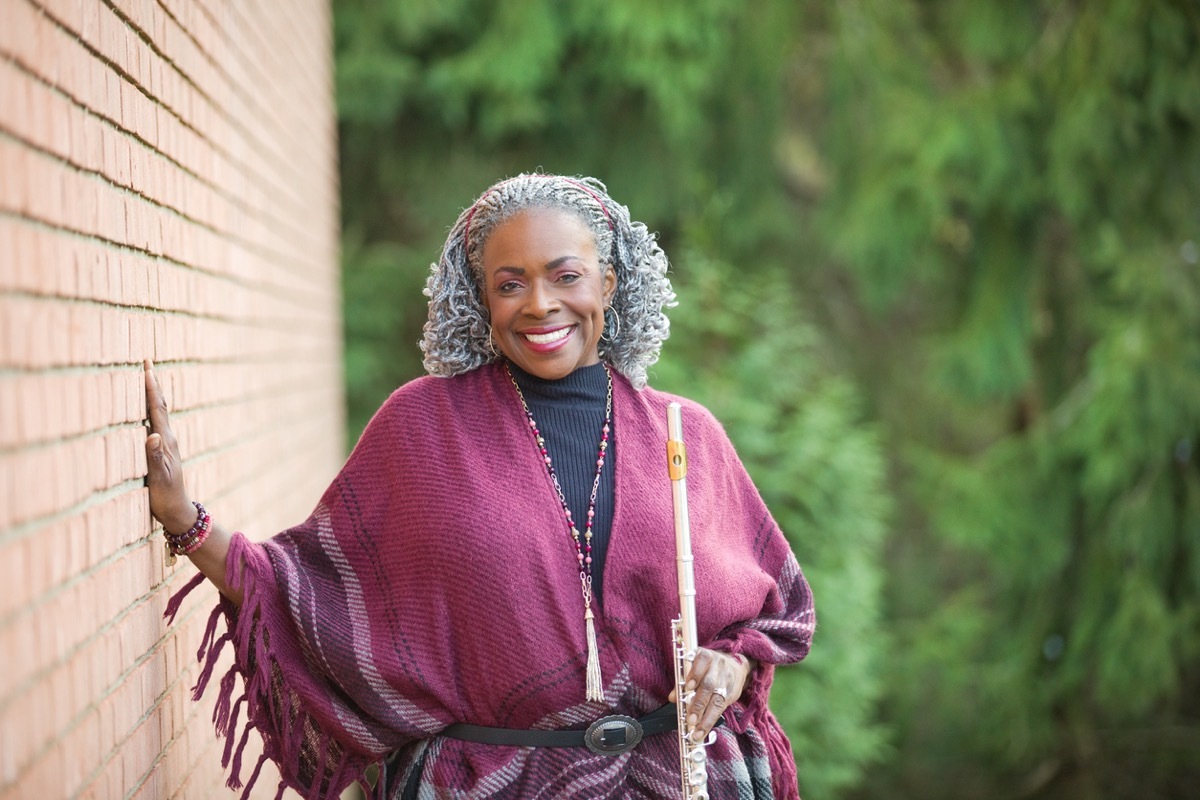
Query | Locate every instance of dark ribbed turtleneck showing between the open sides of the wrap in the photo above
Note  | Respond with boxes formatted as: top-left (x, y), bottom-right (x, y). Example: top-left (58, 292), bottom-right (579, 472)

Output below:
top-left (509, 362), bottom-right (617, 602)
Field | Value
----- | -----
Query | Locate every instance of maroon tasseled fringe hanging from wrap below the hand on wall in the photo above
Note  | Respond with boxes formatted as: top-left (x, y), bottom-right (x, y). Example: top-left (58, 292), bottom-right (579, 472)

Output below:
top-left (163, 535), bottom-right (372, 800)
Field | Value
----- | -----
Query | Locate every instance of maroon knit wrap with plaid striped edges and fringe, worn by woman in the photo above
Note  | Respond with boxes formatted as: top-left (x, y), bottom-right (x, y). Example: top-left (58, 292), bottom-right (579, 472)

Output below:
top-left (168, 365), bottom-right (815, 800)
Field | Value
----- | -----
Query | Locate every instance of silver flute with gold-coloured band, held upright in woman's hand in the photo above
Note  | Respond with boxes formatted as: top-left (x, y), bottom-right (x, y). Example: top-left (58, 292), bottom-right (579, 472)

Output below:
top-left (667, 403), bottom-right (715, 800)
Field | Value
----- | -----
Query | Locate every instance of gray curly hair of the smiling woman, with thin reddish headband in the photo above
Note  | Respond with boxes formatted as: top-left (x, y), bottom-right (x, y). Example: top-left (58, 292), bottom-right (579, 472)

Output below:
top-left (421, 173), bottom-right (676, 389)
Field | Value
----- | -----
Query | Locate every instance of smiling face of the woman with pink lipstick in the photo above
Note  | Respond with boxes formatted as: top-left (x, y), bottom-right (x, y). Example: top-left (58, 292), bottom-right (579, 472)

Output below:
top-left (482, 207), bottom-right (617, 380)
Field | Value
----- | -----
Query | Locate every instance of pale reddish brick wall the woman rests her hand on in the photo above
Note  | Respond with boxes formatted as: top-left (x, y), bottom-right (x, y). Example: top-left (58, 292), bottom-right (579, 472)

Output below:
top-left (0, 0), bottom-right (343, 800)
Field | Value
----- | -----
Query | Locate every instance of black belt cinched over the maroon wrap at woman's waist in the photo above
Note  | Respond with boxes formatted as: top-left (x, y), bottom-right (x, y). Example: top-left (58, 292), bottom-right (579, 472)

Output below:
top-left (442, 703), bottom-right (679, 756)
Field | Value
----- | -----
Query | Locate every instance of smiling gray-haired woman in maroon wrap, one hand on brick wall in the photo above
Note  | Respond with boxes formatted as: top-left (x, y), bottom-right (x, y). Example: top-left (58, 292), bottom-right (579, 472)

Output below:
top-left (146, 174), bottom-right (815, 800)
